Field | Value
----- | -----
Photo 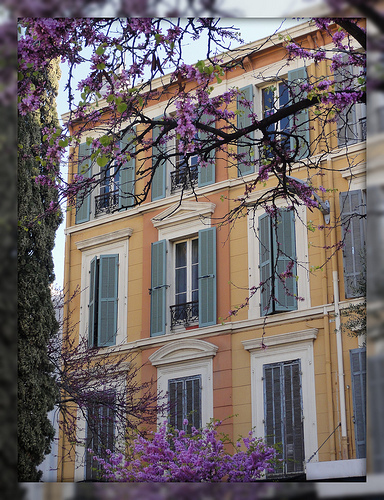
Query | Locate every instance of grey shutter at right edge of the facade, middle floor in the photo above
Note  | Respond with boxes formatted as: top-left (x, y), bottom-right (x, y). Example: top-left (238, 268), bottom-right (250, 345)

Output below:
top-left (340, 189), bottom-right (365, 298)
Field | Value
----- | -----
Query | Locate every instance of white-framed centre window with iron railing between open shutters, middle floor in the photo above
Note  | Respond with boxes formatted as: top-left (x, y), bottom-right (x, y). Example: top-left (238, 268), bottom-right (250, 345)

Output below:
top-left (171, 238), bottom-right (199, 330)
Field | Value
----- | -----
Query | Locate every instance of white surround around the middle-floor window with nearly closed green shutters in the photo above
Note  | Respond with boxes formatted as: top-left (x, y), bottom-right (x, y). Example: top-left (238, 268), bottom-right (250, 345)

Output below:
top-left (248, 200), bottom-right (311, 319)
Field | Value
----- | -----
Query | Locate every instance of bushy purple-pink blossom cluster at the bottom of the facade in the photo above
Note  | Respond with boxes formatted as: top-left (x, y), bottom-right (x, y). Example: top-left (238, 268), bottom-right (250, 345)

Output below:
top-left (90, 420), bottom-right (276, 482)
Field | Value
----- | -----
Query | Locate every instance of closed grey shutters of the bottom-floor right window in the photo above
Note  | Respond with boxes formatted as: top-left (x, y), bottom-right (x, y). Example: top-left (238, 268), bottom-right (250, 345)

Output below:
top-left (263, 359), bottom-right (304, 474)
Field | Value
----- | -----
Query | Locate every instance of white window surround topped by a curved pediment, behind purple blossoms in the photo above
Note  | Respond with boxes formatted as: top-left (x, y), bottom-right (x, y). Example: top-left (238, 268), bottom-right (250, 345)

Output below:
top-left (149, 339), bottom-right (218, 427)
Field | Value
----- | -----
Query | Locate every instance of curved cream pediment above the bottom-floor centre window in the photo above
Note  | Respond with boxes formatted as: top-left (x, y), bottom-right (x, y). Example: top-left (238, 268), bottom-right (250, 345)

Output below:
top-left (149, 339), bottom-right (219, 366)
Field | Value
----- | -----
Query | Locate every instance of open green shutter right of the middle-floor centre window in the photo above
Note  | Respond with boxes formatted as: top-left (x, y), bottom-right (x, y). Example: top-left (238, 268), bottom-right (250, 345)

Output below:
top-left (198, 227), bottom-right (216, 327)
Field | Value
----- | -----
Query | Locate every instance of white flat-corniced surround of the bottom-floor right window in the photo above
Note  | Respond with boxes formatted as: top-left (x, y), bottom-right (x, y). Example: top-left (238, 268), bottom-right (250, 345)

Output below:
top-left (242, 328), bottom-right (318, 463)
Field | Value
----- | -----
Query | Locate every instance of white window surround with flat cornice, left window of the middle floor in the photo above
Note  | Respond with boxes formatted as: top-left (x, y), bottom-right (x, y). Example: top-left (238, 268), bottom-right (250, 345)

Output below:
top-left (76, 228), bottom-right (132, 349)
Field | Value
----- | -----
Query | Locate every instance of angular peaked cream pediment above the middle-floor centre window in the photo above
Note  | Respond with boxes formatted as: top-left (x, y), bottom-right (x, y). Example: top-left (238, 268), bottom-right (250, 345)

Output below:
top-left (151, 200), bottom-right (216, 240)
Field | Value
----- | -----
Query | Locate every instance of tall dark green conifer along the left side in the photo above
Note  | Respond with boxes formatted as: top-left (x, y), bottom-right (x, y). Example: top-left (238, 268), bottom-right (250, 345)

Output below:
top-left (17, 59), bottom-right (62, 481)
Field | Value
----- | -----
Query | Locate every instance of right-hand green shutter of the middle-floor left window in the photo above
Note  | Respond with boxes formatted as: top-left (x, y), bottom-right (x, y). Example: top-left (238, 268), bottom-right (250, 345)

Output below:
top-left (98, 255), bottom-right (119, 347)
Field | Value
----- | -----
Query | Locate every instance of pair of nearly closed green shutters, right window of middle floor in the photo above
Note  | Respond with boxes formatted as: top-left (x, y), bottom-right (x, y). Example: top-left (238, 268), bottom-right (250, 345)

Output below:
top-left (258, 210), bottom-right (297, 316)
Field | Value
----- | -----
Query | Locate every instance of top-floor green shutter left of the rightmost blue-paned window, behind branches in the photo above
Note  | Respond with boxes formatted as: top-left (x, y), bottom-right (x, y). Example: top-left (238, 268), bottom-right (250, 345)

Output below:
top-left (237, 85), bottom-right (255, 177)
